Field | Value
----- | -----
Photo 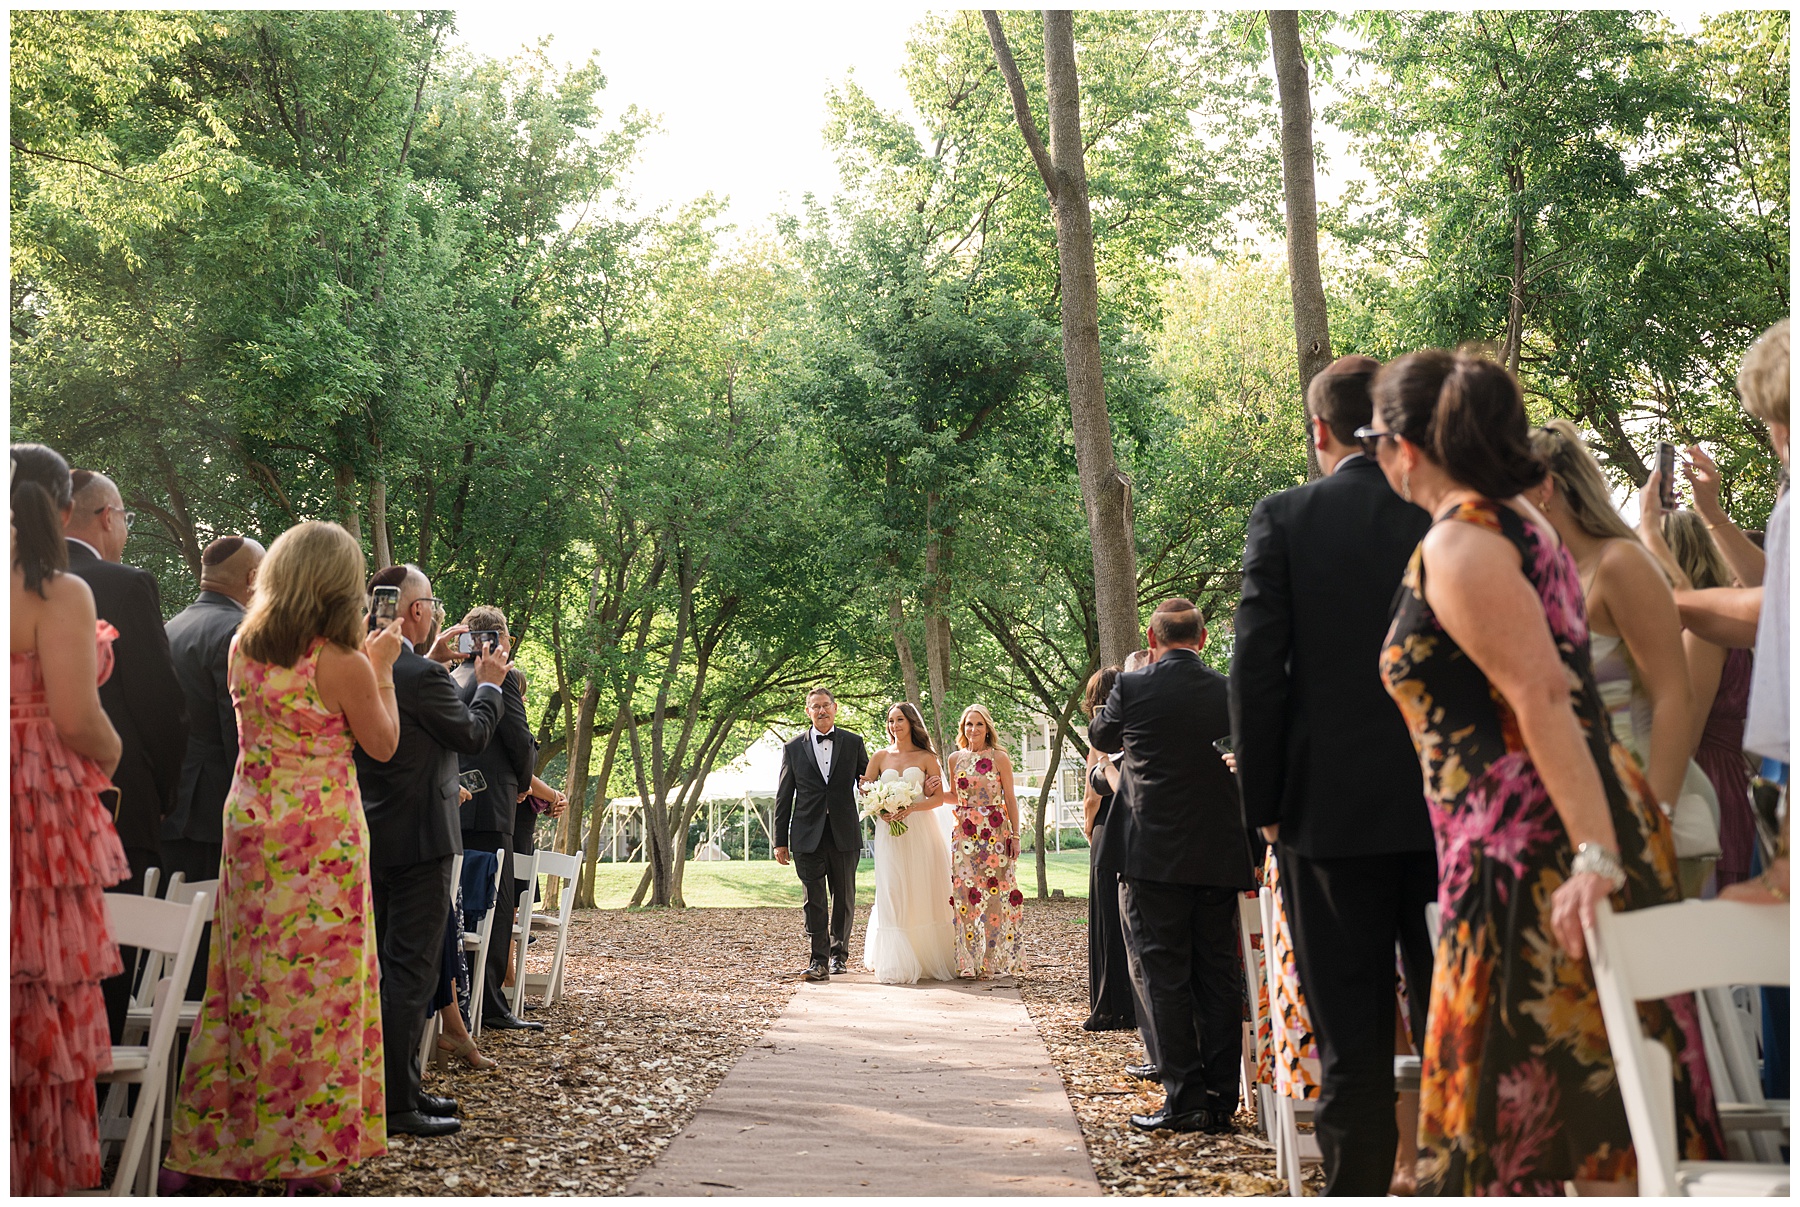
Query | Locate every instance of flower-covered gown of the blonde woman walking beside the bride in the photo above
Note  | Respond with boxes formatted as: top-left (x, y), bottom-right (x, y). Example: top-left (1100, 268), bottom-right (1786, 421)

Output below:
top-left (950, 750), bottom-right (1024, 977)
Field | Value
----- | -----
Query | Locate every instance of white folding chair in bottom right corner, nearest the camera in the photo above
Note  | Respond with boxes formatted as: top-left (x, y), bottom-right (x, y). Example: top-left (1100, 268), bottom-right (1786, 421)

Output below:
top-left (1588, 901), bottom-right (1789, 1196)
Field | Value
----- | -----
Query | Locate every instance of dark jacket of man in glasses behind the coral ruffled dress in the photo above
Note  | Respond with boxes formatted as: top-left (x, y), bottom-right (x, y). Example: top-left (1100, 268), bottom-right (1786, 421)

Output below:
top-left (68, 541), bottom-right (187, 853)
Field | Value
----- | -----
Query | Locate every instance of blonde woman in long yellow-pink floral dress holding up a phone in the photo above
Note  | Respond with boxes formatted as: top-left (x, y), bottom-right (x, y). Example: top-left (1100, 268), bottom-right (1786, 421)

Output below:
top-left (162, 522), bottom-right (401, 1193)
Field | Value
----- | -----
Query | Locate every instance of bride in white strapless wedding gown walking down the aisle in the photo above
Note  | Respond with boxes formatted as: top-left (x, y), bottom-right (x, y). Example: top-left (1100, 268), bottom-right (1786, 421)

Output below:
top-left (862, 702), bottom-right (956, 984)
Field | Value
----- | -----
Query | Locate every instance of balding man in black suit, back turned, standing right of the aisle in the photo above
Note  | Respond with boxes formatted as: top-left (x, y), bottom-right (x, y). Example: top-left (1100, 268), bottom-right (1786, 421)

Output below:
top-left (1087, 597), bottom-right (1256, 1133)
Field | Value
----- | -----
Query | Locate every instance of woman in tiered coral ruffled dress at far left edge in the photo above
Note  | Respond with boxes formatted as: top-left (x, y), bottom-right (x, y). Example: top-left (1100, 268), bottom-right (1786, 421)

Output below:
top-left (9, 444), bottom-right (128, 1194)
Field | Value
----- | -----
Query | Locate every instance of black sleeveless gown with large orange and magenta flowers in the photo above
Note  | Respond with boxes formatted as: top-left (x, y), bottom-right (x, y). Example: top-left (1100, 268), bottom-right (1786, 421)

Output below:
top-left (1381, 500), bottom-right (1723, 1194)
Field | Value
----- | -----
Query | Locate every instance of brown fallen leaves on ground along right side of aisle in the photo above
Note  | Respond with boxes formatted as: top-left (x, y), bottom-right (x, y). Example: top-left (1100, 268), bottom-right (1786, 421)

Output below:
top-left (1019, 899), bottom-right (1323, 1194)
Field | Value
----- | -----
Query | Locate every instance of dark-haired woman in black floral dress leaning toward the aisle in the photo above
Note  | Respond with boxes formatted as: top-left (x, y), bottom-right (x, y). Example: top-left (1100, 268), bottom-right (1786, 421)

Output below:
top-left (1363, 351), bottom-right (1721, 1194)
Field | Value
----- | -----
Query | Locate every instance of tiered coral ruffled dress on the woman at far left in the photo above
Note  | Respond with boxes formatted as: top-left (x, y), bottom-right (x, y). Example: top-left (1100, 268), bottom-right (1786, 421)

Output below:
top-left (11, 621), bottom-right (131, 1194)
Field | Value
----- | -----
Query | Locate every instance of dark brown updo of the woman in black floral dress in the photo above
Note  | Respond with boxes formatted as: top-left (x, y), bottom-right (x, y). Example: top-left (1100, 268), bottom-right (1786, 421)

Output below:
top-left (1370, 349), bottom-right (1544, 498)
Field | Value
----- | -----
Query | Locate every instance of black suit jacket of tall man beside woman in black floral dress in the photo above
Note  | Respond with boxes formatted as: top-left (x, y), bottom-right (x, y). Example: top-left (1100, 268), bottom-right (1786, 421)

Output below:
top-left (1231, 457), bottom-right (1433, 858)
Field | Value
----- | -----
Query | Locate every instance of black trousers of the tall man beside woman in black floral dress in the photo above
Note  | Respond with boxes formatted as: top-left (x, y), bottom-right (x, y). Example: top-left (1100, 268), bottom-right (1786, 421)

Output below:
top-left (1276, 845), bottom-right (1438, 1194)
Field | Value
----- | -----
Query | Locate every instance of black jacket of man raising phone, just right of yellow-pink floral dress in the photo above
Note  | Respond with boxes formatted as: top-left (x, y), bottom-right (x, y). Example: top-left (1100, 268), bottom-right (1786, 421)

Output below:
top-left (356, 649), bottom-right (500, 867)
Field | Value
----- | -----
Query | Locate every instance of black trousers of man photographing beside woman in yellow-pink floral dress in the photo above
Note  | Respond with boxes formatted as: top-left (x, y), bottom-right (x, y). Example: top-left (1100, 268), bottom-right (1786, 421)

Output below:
top-left (369, 854), bottom-right (452, 1115)
